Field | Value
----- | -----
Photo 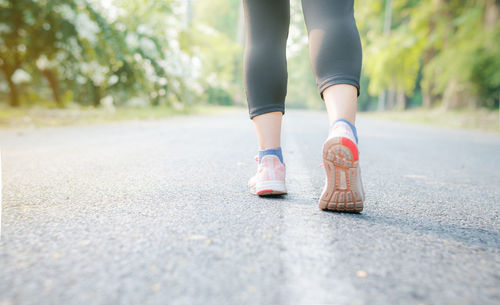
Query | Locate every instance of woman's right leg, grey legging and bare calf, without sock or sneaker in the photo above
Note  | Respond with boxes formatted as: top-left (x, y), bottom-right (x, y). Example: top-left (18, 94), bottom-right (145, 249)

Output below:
top-left (302, 0), bottom-right (361, 125)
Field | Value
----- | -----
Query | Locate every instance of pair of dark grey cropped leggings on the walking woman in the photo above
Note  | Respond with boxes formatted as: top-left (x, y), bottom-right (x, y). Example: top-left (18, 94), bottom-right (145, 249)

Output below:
top-left (243, 0), bottom-right (361, 118)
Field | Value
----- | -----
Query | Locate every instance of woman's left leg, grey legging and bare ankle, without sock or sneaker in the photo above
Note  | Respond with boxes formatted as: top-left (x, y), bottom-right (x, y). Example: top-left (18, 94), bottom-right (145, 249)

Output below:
top-left (243, 0), bottom-right (290, 150)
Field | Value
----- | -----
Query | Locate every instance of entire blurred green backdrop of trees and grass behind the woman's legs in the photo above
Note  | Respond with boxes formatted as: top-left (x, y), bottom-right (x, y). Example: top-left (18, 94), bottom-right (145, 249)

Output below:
top-left (0, 0), bottom-right (500, 129)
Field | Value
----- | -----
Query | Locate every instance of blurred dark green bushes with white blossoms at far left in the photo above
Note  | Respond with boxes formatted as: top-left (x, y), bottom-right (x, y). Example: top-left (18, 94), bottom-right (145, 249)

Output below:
top-left (0, 0), bottom-right (207, 107)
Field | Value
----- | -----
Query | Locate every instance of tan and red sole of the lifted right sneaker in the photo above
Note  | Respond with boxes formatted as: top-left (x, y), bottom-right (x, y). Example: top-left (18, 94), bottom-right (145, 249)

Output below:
top-left (319, 137), bottom-right (363, 213)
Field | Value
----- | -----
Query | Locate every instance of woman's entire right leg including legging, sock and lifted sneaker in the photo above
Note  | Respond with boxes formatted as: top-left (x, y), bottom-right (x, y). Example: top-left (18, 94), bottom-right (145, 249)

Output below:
top-left (302, 0), bottom-right (364, 212)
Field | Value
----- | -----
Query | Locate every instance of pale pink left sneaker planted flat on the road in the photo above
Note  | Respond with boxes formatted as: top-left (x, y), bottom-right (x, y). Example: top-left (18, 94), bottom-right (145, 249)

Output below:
top-left (248, 155), bottom-right (286, 196)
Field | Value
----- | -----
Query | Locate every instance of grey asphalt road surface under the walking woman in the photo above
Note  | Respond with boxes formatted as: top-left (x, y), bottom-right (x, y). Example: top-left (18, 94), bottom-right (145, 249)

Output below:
top-left (0, 111), bottom-right (500, 305)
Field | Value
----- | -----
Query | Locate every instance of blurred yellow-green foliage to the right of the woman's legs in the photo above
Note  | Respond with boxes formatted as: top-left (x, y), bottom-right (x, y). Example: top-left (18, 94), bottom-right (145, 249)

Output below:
top-left (357, 0), bottom-right (500, 108)
